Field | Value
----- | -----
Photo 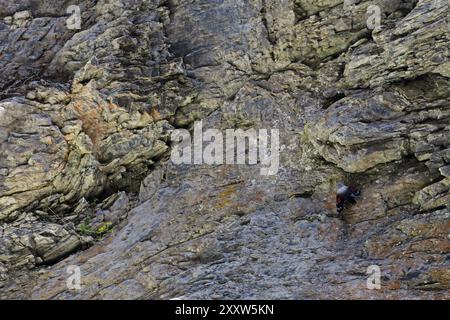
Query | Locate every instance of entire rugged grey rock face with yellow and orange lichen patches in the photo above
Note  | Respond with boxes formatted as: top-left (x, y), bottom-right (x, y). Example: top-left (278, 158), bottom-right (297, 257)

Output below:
top-left (0, 0), bottom-right (450, 299)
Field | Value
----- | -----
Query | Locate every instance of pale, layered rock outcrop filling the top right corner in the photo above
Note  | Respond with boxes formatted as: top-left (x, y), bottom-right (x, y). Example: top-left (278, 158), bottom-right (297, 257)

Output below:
top-left (344, 0), bottom-right (450, 87)
